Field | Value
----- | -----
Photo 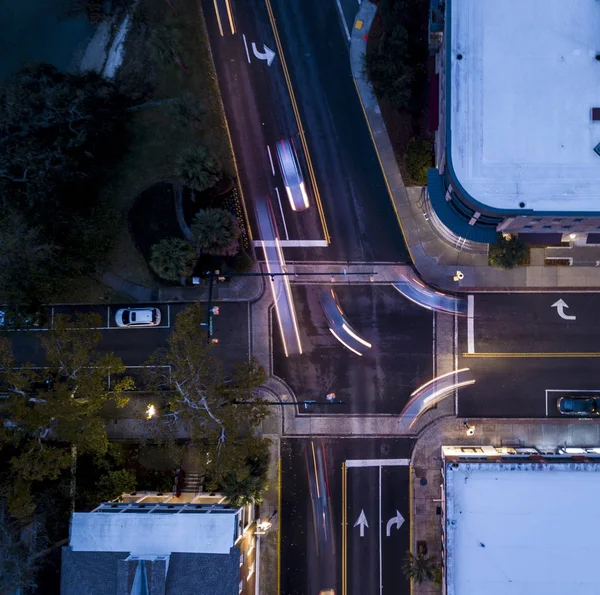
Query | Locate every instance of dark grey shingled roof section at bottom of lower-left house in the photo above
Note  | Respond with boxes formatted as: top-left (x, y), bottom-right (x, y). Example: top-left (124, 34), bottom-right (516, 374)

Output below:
top-left (60, 548), bottom-right (240, 595)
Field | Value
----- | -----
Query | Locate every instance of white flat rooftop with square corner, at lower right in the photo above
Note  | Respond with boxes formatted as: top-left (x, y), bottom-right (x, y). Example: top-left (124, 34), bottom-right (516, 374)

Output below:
top-left (446, 463), bottom-right (600, 595)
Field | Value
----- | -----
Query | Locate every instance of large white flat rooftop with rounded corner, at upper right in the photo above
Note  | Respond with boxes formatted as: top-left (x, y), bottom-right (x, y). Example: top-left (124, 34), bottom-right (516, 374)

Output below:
top-left (446, 0), bottom-right (600, 212)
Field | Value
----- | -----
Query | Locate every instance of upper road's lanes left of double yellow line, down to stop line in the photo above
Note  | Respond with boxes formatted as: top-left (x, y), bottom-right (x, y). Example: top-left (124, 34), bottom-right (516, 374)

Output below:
top-left (202, 0), bottom-right (324, 249)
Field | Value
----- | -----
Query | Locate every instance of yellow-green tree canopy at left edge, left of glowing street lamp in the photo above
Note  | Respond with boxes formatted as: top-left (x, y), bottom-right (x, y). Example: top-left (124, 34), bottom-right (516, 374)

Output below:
top-left (0, 314), bottom-right (133, 516)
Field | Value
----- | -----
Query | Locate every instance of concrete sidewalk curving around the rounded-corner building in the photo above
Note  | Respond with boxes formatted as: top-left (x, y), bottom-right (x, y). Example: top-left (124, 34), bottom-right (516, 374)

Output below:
top-left (350, 1), bottom-right (600, 291)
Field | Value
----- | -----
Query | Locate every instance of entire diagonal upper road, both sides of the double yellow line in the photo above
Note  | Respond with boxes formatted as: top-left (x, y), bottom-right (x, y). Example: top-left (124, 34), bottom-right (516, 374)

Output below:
top-left (203, 0), bottom-right (409, 262)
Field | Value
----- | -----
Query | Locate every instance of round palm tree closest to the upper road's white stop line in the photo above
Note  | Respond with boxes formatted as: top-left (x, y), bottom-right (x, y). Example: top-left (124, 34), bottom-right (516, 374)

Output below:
top-left (191, 209), bottom-right (241, 256)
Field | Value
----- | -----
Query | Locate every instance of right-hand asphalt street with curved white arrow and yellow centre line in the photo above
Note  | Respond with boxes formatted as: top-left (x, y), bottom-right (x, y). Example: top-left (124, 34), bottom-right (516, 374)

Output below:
top-left (458, 293), bottom-right (600, 423)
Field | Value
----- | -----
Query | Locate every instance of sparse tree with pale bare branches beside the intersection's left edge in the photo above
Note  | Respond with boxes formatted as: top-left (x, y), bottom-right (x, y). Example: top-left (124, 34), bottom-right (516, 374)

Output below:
top-left (143, 303), bottom-right (268, 495)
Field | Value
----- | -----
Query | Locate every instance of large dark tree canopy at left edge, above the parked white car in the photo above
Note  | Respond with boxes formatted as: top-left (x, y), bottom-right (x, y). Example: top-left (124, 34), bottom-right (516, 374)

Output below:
top-left (0, 64), bottom-right (131, 306)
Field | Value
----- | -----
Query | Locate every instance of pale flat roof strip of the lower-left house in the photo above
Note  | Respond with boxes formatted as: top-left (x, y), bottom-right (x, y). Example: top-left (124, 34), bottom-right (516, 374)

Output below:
top-left (69, 512), bottom-right (239, 555)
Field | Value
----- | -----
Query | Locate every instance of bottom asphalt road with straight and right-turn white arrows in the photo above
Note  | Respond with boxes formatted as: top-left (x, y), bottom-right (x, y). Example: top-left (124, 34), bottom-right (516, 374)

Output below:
top-left (279, 438), bottom-right (413, 595)
